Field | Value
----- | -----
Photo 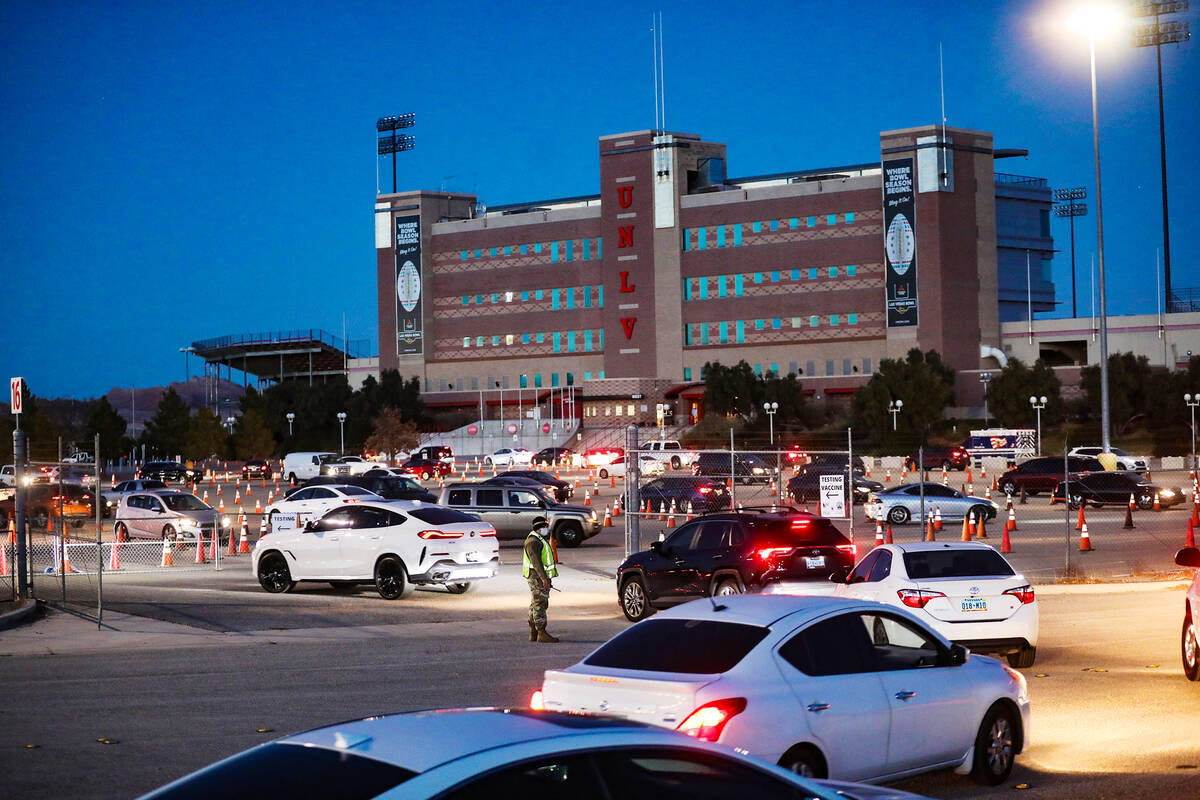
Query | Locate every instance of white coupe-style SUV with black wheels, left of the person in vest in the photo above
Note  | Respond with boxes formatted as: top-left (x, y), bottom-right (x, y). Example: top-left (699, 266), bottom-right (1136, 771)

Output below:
top-left (251, 503), bottom-right (500, 600)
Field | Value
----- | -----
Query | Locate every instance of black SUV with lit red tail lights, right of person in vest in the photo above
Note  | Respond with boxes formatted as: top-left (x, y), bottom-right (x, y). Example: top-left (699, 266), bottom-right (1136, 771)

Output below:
top-left (617, 509), bottom-right (854, 622)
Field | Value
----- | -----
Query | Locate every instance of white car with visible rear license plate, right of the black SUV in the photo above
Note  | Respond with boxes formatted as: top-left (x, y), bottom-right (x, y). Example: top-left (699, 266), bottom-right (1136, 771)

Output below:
top-left (835, 542), bottom-right (1038, 668)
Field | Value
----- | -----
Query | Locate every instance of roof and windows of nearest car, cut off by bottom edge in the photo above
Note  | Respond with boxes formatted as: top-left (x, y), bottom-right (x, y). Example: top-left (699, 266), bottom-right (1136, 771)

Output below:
top-left (136, 709), bottom-right (918, 800)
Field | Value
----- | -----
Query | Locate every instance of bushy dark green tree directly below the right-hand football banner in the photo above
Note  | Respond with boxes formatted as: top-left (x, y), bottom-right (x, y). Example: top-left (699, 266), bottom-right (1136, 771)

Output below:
top-left (851, 348), bottom-right (954, 443)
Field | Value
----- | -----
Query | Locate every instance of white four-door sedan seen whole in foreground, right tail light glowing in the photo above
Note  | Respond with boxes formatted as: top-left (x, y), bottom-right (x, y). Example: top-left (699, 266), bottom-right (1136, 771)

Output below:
top-left (541, 595), bottom-right (1030, 786)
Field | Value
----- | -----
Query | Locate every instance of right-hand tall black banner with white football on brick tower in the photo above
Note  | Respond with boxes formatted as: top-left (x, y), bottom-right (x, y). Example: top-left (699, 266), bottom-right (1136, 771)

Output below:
top-left (883, 158), bottom-right (917, 327)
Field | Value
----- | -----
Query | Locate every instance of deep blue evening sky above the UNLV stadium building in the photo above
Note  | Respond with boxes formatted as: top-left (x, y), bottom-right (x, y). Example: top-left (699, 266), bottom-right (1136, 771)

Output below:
top-left (0, 0), bottom-right (1200, 398)
